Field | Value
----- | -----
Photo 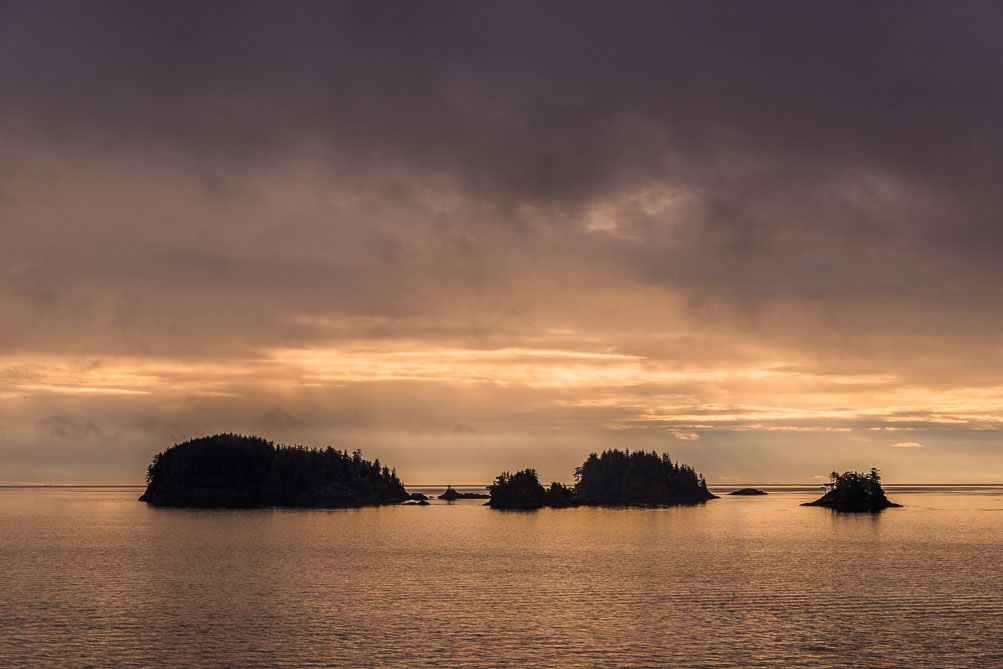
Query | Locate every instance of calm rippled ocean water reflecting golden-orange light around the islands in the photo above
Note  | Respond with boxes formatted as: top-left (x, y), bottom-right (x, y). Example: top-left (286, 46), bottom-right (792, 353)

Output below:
top-left (0, 485), bottom-right (1003, 667)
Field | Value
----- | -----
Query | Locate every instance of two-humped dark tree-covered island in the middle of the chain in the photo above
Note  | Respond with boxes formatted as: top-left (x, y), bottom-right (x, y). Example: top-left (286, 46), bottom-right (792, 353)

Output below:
top-left (487, 449), bottom-right (717, 510)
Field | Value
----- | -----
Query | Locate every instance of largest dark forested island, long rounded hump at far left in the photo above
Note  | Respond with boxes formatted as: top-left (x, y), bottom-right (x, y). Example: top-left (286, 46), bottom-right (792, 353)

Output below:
top-left (139, 434), bottom-right (408, 508)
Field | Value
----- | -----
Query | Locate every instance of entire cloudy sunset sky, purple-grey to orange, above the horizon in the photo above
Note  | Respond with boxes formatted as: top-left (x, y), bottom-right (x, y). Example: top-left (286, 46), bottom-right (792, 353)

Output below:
top-left (0, 0), bottom-right (1003, 484)
